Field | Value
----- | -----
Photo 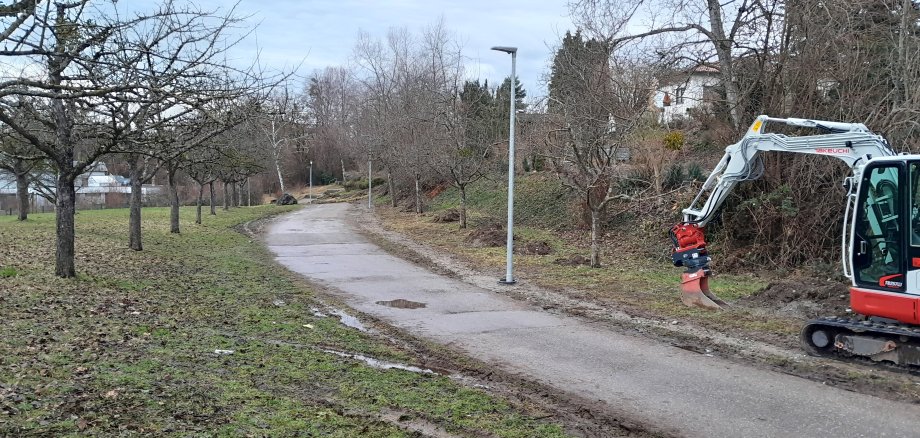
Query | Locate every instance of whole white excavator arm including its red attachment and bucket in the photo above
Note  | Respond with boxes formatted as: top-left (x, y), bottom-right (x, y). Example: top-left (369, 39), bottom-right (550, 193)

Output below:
top-left (671, 115), bottom-right (895, 309)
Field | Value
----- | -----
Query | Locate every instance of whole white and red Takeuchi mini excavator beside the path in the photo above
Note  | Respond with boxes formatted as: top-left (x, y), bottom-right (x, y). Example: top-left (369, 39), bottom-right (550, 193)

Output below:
top-left (670, 115), bottom-right (920, 370)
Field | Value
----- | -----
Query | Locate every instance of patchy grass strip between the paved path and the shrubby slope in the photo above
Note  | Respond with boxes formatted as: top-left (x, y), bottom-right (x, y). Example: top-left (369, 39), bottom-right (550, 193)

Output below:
top-left (377, 175), bottom-right (801, 346)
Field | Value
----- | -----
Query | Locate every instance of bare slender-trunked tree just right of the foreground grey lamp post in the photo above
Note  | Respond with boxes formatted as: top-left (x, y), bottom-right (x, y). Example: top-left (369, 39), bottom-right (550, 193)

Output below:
top-left (546, 34), bottom-right (655, 267)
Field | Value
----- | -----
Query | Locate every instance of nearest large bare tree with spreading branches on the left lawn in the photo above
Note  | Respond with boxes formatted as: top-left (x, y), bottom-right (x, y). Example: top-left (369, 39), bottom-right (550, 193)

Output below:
top-left (0, 0), bottom-right (270, 277)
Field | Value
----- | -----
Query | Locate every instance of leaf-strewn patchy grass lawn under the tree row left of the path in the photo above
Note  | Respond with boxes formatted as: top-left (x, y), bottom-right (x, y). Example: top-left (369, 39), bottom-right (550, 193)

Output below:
top-left (0, 206), bottom-right (563, 437)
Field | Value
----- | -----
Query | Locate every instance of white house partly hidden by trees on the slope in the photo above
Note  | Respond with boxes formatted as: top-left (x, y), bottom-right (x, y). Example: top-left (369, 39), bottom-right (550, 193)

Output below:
top-left (655, 64), bottom-right (721, 124)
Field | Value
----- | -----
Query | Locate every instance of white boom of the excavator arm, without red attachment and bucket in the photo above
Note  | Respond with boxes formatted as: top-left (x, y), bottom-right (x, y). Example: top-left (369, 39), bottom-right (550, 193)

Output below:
top-left (683, 116), bottom-right (895, 227)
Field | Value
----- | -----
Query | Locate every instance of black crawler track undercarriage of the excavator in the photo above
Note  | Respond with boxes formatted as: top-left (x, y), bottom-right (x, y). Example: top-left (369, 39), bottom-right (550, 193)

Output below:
top-left (801, 316), bottom-right (920, 370)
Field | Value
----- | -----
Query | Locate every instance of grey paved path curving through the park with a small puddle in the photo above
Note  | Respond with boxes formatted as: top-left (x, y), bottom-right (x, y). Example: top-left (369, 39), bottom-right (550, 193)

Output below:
top-left (266, 204), bottom-right (920, 438)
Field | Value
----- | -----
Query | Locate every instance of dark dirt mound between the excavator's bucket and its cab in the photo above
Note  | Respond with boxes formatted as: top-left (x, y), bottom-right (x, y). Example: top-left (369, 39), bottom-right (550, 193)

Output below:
top-left (740, 277), bottom-right (850, 318)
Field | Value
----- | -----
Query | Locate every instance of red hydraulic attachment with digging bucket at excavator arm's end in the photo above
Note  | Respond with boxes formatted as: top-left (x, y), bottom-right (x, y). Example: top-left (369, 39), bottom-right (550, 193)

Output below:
top-left (671, 223), bottom-right (727, 309)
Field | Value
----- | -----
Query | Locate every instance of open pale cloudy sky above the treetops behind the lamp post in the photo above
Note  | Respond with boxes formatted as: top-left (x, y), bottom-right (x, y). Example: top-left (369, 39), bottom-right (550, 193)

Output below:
top-left (134, 0), bottom-right (572, 101)
